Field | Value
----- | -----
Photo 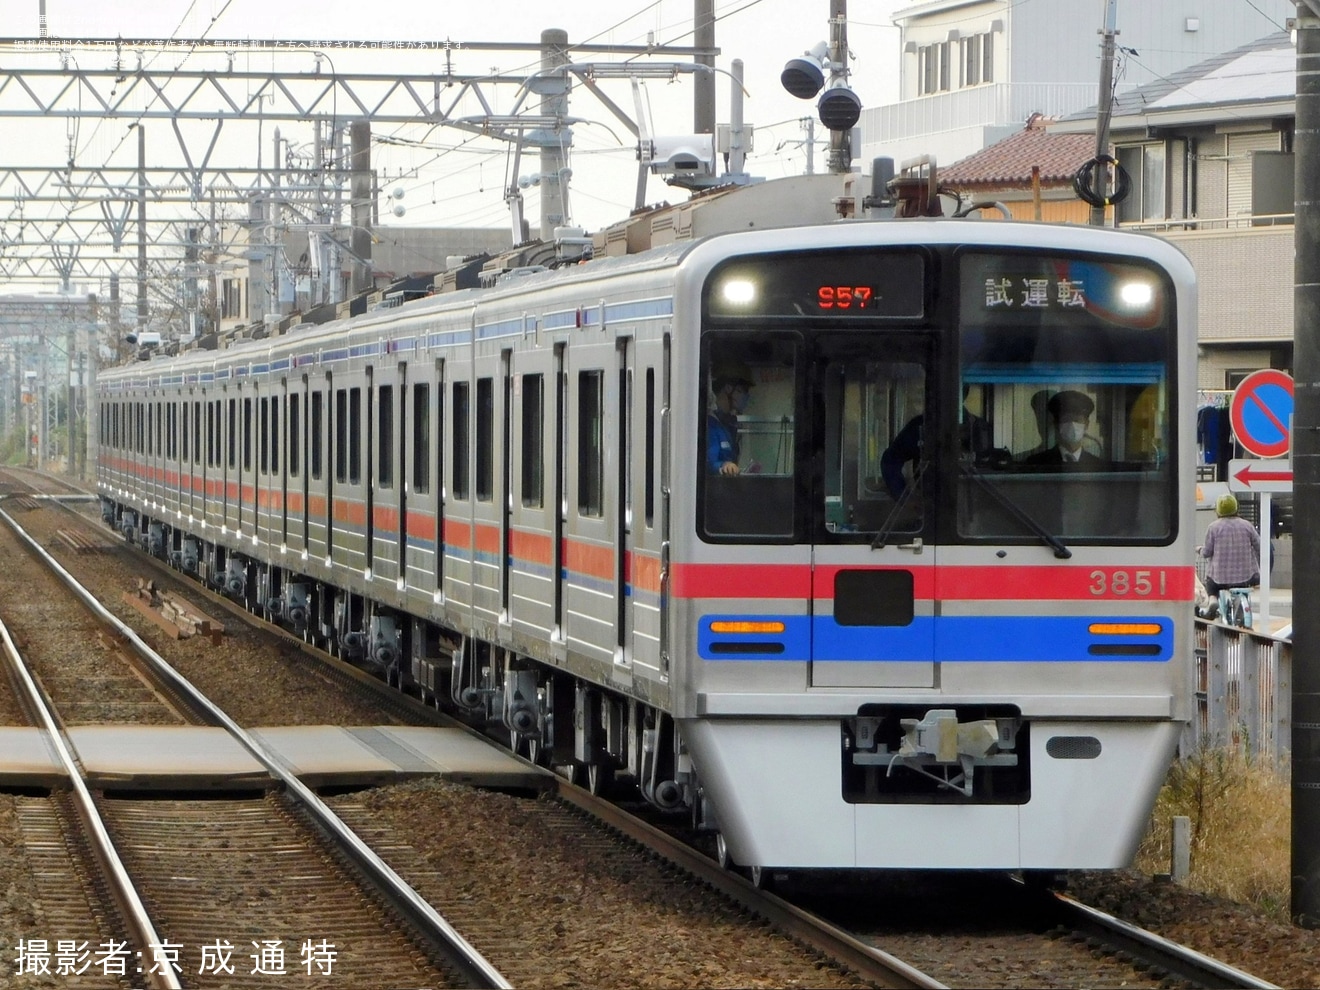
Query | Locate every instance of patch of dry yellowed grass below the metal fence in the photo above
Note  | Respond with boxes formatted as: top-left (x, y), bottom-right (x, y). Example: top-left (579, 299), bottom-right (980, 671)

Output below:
top-left (1135, 750), bottom-right (1292, 921)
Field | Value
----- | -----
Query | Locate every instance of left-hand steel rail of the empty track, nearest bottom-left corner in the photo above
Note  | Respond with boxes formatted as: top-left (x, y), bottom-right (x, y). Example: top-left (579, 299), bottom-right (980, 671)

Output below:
top-left (0, 612), bottom-right (182, 990)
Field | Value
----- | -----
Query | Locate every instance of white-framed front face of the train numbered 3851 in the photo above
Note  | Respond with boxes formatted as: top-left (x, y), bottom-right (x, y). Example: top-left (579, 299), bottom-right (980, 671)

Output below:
top-left (671, 220), bottom-right (1196, 870)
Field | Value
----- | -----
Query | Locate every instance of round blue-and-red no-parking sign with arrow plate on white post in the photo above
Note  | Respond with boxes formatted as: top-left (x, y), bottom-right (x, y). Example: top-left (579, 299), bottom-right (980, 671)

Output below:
top-left (1229, 368), bottom-right (1294, 635)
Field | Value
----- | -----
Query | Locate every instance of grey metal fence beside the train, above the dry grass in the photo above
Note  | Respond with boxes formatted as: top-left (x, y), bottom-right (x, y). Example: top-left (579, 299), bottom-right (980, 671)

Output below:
top-left (1181, 619), bottom-right (1292, 768)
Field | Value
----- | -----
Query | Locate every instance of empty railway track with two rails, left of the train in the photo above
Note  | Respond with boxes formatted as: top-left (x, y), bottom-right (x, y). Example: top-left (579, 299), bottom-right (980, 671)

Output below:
top-left (0, 496), bottom-right (507, 987)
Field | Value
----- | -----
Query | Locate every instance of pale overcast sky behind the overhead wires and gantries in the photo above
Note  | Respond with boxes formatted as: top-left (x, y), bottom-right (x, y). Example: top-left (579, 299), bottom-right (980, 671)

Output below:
top-left (0, 0), bottom-right (906, 230)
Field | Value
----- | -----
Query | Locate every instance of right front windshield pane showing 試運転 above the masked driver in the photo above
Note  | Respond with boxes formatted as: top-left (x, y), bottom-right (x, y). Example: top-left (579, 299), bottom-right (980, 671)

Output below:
top-left (956, 253), bottom-right (1176, 543)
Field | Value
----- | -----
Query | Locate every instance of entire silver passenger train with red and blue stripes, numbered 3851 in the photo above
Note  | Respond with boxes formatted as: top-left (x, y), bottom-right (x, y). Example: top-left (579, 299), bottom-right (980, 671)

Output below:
top-left (96, 207), bottom-right (1196, 874)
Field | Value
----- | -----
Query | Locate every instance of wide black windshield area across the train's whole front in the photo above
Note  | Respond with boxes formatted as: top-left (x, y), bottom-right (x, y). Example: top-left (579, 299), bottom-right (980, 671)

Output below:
top-left (698, 251), bottom-right (1177, 552)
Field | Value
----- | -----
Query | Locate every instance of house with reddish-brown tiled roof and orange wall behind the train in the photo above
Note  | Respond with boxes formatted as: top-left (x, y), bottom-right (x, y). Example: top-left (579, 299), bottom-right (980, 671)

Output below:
top-left (939, 114), bottom-right (1096, 223)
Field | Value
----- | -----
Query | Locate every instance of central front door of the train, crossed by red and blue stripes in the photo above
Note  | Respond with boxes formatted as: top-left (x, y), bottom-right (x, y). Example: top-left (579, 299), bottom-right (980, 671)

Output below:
top-left (809, 333), bottom-right (941, 688)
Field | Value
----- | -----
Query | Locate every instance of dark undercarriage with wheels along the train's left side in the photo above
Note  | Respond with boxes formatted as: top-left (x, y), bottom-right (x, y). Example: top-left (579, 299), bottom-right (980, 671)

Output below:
top-left (102, 498), bottom-right (714, 828)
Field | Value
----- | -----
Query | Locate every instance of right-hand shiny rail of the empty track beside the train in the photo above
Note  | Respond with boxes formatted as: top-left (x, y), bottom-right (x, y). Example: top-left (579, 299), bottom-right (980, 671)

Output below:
top-left (0, 510), bottom-right (512, 990)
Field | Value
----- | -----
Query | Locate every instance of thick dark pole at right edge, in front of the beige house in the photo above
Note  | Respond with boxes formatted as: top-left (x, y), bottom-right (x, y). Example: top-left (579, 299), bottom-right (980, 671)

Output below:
top-left (1288, 0), bottom-right (1320, 928)
